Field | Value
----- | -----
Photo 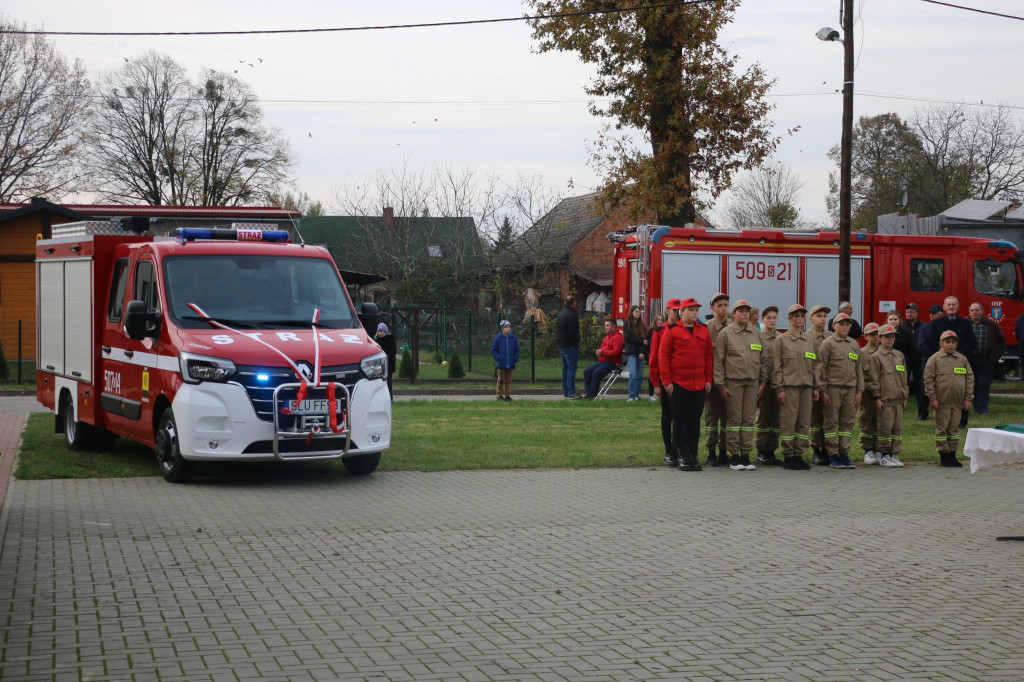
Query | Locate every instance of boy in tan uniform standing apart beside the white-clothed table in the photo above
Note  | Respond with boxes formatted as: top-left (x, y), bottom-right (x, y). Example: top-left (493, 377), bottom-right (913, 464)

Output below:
top-left (925, 330), bottom-right (974, 467)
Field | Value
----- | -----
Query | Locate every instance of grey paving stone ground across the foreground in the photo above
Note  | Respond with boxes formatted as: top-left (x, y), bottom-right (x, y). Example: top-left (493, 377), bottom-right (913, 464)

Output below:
top-left (0, 458), bottom-right (1024, 682)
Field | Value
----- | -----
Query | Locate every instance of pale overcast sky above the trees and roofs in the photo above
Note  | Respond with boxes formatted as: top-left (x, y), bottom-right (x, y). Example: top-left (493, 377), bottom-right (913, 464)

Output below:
top-left (8, 0), bottom-right (1024, 220)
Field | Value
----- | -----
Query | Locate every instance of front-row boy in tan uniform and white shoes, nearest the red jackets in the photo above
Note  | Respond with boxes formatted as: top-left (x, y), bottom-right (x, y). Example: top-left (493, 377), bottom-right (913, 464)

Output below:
top-left (715, 300), bottom-right (771, 471)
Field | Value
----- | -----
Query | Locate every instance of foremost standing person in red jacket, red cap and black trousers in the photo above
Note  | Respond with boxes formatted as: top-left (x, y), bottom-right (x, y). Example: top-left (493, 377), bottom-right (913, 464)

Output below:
top-left (657, 298), bottom-right (714, 471)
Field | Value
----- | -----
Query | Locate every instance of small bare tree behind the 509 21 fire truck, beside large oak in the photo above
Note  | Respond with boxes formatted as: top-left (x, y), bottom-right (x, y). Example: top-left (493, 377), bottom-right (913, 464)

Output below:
top-left (724, 163), bottom-right (804, 228)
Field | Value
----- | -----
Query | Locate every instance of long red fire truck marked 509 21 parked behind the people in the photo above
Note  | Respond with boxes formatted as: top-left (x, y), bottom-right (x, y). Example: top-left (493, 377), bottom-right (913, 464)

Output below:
top-left (609, 225), bottom-right (1024, 347)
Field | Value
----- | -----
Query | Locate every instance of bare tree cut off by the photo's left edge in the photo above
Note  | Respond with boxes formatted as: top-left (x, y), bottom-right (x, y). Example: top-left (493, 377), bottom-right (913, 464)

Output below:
top-left (0, 17), bottom-right (89, 202)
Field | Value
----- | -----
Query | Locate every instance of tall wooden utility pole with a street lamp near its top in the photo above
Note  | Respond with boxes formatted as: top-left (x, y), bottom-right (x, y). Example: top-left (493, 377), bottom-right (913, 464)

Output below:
top-left (815, 0), bottom-right (853, 301)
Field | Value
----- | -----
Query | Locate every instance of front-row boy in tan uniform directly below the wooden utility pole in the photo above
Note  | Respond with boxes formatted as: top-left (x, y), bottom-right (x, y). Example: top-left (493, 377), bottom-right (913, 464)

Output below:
top-left (818, 312), bottom-right (864, 469)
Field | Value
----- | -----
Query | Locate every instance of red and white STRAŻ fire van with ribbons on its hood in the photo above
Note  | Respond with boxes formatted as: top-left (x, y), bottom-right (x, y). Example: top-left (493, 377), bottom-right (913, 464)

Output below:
top-left (36, 222), bottom-right (391, 482)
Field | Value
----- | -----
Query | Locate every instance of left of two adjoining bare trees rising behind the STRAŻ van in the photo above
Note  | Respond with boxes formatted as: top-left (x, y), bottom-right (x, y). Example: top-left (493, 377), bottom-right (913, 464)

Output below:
top-left (91, 51), bottom-right (199, 206)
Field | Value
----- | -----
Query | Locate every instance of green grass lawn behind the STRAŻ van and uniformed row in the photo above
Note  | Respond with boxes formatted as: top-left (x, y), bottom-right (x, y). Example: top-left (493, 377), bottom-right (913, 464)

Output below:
top-left (16, 396), bottom-right (1024, 479)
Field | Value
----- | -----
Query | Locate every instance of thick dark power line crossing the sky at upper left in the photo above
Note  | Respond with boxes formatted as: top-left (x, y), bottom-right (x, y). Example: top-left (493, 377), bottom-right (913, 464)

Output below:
top-left (0, 0), bottom-right (720, 36)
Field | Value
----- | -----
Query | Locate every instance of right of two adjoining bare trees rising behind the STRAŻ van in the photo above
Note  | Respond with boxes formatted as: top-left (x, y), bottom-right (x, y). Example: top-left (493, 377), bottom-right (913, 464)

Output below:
top-left (189, 72), bottom-right (293, 206)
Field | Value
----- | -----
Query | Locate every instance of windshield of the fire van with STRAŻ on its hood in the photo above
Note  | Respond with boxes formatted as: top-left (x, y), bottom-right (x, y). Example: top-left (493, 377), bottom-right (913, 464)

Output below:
top-left (164, 254), bottom-right (358, 329)
